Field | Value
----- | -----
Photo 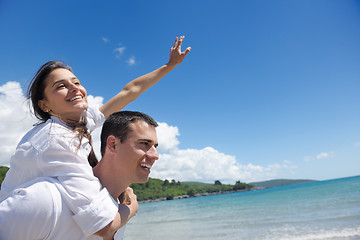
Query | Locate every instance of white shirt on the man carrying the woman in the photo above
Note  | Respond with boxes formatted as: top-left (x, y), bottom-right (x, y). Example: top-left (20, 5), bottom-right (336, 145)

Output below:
top-left (0, 178), bottom-right (125, 240)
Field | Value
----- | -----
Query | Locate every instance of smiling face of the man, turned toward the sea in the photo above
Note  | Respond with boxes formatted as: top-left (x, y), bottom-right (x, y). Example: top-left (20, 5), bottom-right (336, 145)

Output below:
top-left (116, 120), bottom-right (159, 183)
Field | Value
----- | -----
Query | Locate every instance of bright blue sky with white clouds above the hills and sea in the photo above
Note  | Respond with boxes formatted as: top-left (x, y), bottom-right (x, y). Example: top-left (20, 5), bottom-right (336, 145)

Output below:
top-left (0, 0), bottom-right (360, 182)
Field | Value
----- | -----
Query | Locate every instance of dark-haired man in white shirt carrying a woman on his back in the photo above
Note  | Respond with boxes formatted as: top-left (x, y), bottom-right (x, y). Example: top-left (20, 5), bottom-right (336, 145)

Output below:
top-left (0, 111), bottom-right (159, 239)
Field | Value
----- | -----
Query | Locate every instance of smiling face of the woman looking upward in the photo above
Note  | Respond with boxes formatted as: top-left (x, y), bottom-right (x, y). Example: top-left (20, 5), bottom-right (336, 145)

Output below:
top-left (38, 68), bottom-right (88, 121)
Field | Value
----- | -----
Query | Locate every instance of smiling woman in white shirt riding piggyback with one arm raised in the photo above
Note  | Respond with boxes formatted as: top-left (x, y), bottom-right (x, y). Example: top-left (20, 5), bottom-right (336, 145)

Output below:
top-left (0, 36), bottom-right (190, 238)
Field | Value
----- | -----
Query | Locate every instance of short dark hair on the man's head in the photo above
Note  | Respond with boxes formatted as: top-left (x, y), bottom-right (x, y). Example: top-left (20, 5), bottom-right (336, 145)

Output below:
top-left (101, 111), bottom-right (158, 156)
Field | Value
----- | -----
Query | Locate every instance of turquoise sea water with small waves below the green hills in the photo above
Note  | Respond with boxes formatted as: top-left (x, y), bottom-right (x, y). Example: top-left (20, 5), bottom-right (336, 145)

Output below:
top-left (125, 176), bottom-right (360, 240)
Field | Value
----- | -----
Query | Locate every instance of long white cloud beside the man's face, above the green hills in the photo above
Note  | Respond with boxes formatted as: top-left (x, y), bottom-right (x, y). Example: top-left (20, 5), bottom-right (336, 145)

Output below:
top-left (151, 123), bottom-right (296, 183)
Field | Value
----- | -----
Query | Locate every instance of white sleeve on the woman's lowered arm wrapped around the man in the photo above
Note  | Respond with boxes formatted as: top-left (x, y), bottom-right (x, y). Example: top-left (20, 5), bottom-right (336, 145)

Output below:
top-left (37, 134), bottom-right (118, 235)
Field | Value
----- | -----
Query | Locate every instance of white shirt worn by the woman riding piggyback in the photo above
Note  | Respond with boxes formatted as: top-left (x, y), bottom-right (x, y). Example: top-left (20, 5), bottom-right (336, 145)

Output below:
top-left (0, 107), bottom-right (118, 236)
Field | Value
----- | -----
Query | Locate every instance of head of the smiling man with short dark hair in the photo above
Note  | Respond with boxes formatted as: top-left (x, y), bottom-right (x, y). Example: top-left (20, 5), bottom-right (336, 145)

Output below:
top-left (101, 111), bottom-right (159, 186)
